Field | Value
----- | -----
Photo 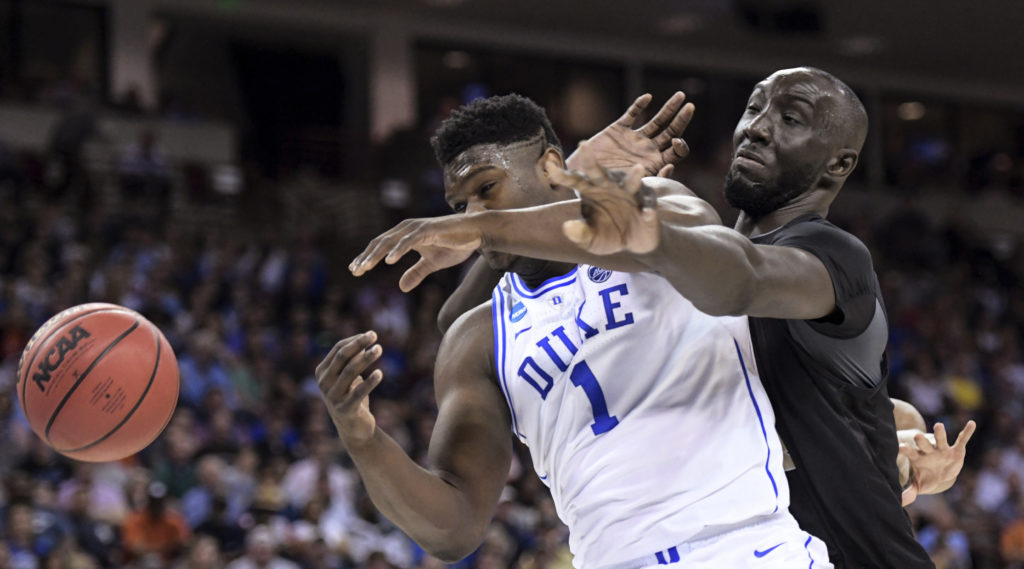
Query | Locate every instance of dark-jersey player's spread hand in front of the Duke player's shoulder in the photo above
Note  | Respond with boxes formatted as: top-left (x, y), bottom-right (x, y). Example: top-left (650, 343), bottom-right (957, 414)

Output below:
top-left (545, 142), bottom-right (659, 255)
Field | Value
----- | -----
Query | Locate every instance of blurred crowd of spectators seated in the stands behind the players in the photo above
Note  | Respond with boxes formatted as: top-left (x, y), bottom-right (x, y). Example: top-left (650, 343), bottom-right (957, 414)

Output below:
top-left (0, 118), bottom-right (1024, 569)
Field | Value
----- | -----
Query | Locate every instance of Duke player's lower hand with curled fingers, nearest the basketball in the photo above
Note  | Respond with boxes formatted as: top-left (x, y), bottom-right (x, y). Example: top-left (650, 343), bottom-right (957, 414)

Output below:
top-left (316, 331), bottom-right (384, 447)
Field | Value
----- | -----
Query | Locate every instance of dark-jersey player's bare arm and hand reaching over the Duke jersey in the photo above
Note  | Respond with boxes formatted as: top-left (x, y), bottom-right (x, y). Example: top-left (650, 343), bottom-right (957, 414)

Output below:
top-left (547, 144), bottom-right (836, 319)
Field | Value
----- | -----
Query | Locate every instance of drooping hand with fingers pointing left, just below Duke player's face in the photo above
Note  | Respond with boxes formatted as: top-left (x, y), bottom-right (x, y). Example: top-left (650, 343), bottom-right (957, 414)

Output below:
top-left (348, 214), bottom-right (483, 293)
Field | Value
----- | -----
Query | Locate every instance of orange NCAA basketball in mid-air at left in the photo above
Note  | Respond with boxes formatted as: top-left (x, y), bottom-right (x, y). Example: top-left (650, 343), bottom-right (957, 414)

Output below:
top-left (17, 303), bottom-right (180, 463)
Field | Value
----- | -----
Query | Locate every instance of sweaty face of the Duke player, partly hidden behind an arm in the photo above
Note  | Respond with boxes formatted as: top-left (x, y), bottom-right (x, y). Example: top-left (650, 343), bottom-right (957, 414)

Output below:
top-left (444, 135), bottom-right (573, 275)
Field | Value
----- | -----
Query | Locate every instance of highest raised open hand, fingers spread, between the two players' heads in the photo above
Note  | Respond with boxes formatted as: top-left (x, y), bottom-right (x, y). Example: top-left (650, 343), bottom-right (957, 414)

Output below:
top-left (565, 91), bottom-right (693, 177)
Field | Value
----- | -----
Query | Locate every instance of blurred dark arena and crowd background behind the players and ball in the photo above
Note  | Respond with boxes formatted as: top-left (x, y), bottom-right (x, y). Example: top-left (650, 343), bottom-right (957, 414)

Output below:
top-left (0, 0), bottom-right (1024, 569)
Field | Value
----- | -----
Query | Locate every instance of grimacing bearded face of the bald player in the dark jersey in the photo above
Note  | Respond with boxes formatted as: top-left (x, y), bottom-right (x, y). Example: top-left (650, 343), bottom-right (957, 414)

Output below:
top-left (725, 69), bottom-right (856, 219)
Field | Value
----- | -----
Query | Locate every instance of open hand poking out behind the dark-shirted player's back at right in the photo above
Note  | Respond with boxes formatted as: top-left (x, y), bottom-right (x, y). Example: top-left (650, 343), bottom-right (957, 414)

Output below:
top-left (899, 421), bottom-right (977, 506)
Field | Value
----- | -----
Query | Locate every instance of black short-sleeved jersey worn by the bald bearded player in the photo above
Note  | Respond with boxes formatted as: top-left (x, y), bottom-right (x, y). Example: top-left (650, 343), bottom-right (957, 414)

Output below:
top-left (750, 214), bottom-right (934, 569)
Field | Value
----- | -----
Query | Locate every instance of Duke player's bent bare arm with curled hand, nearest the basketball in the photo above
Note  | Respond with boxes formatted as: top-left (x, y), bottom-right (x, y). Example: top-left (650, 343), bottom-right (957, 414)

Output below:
top-left (316, 307), bottom-right (512, 562)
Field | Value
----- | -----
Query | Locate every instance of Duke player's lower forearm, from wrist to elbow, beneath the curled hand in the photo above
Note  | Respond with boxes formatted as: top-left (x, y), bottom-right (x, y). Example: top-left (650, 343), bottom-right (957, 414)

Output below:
top-left (346, 428), bottom-right (489, 562)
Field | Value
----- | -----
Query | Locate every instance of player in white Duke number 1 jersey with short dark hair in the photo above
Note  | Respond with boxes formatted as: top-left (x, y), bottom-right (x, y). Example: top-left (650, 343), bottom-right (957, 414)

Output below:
top-left (327, 96), bottom-right (830, 569)
